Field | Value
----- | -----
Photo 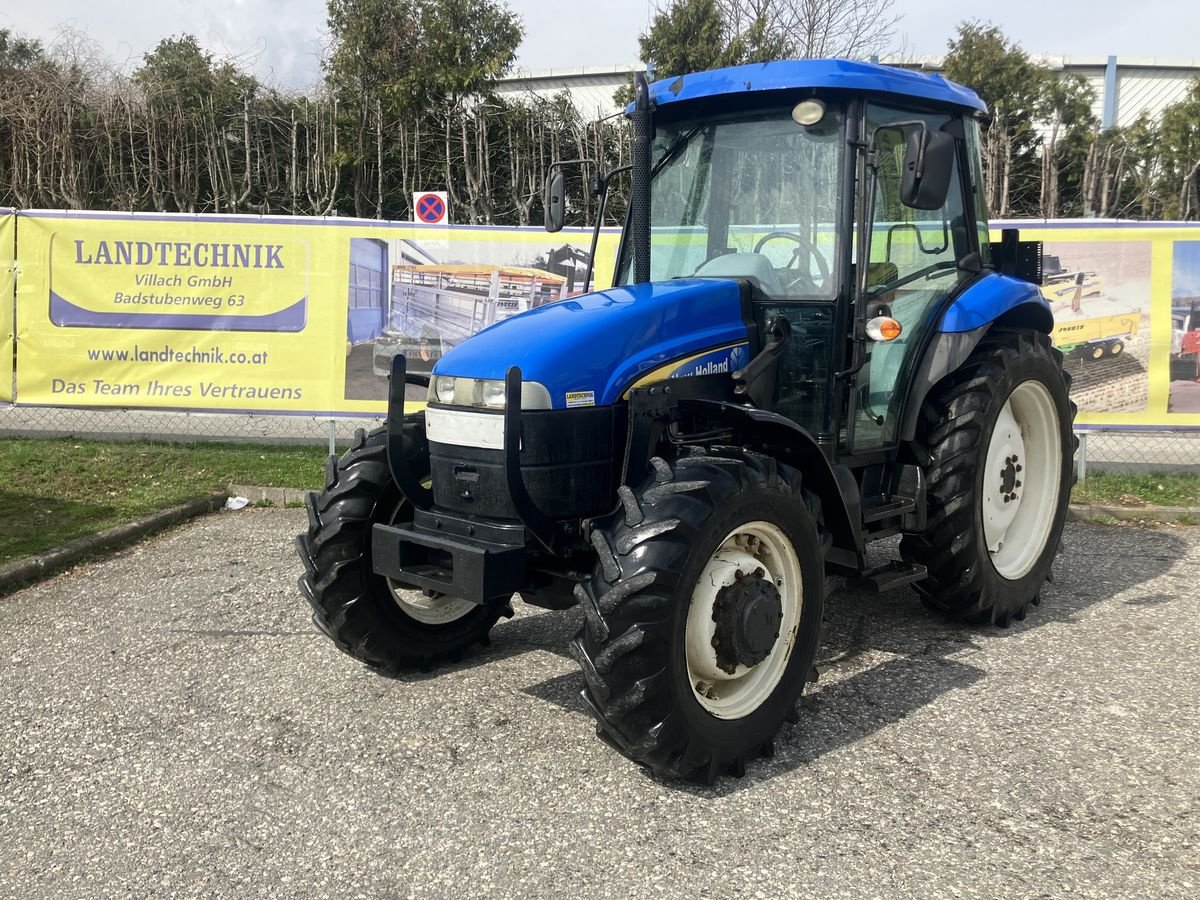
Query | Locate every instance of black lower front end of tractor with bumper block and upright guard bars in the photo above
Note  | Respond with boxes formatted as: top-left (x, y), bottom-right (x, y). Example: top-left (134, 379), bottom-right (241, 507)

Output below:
top-left (371, 355), bottom-right (616, 604)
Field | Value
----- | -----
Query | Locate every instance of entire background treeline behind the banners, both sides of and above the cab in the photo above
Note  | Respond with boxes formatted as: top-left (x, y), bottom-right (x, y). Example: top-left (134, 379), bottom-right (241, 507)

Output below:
top-left (0, 0), bottom-right (1200, 224)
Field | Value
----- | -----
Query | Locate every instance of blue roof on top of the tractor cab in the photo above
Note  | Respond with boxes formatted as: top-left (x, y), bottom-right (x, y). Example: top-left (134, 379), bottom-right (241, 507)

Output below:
top-left (626, 59), bottom-right (988, 113)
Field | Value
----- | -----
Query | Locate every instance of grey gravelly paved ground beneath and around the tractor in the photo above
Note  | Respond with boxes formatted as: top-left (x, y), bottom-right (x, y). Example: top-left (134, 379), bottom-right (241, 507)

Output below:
top-left (0, 510), bottom-right (1200, 899)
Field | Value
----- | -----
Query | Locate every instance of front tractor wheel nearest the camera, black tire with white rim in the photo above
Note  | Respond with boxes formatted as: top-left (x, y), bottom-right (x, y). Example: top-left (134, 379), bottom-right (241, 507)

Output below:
top-left (570, 449), bottom-right (828, 784)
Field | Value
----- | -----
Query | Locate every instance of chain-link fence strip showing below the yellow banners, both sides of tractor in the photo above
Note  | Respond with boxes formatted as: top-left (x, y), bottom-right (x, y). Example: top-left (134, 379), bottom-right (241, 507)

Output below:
top-left (0, 407), bottom-right (1200, 479)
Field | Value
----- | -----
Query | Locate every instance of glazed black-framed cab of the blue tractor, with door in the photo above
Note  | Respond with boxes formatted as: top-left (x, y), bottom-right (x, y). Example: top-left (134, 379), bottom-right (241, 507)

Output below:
top-left (600, 75), bottom-right (990, 454)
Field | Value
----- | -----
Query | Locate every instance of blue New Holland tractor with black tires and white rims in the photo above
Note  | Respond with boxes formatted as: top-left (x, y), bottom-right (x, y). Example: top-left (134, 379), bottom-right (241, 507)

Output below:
top-left (298, 60), bottom-right (1074, 782)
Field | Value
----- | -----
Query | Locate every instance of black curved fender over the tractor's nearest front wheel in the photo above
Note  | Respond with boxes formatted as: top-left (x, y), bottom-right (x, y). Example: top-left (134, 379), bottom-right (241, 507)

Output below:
top-left (678, 398), bottom-right (863, 571)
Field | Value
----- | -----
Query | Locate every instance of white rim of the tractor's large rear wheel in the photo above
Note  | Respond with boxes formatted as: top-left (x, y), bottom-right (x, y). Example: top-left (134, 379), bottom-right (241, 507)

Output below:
top-left (982, 382), bottom-right (1062, 581)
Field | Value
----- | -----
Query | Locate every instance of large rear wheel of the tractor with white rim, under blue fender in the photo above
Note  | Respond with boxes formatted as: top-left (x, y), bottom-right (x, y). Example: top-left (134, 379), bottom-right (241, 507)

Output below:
top-left (900, 329), bottom-right (1076, 626)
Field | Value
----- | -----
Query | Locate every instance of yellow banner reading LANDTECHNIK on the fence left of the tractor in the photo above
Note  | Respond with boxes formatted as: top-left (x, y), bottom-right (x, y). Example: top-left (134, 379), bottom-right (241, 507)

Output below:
top-left (16, 211), bottom-right (616, 415)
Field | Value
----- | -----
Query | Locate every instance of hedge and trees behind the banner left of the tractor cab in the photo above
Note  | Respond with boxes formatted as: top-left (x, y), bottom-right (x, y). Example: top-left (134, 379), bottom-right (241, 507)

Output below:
top-left (0, 0), bottom-right (626, 224)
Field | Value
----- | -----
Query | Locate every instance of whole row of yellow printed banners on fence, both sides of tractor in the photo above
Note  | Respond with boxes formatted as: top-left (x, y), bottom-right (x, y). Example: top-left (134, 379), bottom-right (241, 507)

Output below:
top-left (7, 211), bottom-right (1200, 427)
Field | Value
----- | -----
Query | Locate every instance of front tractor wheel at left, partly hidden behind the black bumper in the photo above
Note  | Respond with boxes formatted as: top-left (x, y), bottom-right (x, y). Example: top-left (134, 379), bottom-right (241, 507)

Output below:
top-left (296, 428), bottom-right (512, 676)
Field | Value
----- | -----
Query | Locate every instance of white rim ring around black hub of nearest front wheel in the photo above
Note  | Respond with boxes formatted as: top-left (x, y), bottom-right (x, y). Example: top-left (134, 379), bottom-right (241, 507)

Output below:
top-left (684, 522), bottom-right (804, 719)
